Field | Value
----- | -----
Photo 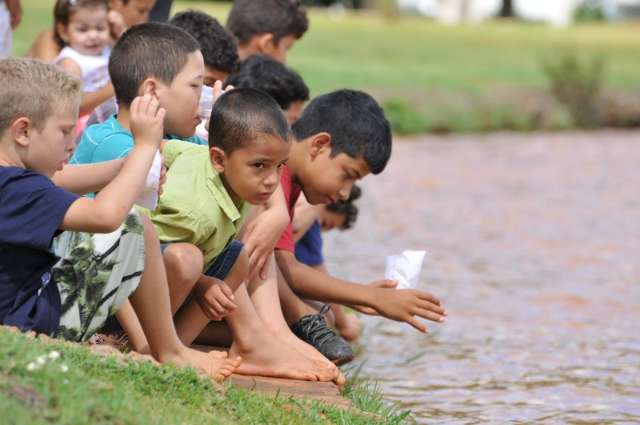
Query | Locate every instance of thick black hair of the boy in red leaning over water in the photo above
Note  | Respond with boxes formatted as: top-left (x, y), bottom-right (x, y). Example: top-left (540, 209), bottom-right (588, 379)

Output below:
top-left (293, 90), bottom-right (391, 174)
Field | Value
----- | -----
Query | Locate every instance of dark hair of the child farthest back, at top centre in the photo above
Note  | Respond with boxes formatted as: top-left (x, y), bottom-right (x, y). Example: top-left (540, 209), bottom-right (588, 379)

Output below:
top-left (227, 0), bottom-right (309, 44)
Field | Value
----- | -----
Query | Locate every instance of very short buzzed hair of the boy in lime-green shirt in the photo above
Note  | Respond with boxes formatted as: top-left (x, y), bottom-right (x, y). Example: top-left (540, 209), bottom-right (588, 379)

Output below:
top-left (209, 88), bottom-right (291, 155)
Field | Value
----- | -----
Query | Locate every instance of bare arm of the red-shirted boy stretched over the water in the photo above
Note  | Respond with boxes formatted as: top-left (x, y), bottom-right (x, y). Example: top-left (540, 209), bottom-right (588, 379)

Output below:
top-left (276, 250), bottom-right (446, 332)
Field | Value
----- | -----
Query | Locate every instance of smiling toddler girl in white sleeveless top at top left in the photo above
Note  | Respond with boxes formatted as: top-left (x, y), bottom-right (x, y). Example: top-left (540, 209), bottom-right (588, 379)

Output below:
top-left (54, 0), bottom-right (114, 129)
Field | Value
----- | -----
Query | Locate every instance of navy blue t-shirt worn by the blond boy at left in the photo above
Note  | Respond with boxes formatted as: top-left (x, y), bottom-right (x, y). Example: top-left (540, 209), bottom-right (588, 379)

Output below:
top-left (0, 167), bottom-right (78, 334)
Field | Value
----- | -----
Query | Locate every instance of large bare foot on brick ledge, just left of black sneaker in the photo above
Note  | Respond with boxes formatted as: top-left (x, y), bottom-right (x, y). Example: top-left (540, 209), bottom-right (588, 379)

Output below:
top-left (229, 332), bottom-right (336, 381)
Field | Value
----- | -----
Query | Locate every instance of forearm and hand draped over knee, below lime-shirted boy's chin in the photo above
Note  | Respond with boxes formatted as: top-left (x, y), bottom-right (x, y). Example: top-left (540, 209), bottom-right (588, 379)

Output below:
top-left (242, 185), bottom-right (289, 279)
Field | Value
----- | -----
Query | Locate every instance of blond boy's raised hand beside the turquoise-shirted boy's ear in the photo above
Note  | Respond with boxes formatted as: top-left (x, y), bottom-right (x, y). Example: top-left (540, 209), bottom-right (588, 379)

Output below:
top-left (129, 94), bottom-right (165, 149)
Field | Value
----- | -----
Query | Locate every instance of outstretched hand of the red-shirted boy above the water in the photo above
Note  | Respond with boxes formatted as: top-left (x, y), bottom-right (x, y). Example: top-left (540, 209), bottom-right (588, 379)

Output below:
top-left (354, 280), bottom-right (447, 332)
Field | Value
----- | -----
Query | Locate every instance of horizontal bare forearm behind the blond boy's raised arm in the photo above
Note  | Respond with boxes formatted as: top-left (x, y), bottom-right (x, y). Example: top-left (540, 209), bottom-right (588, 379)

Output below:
top-left (52, 159), bottom-right (125, 195)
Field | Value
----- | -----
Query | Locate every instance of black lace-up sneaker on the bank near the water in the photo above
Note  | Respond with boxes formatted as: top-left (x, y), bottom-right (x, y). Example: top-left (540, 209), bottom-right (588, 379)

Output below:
top-left (291, 304), bottom-right (353, 366)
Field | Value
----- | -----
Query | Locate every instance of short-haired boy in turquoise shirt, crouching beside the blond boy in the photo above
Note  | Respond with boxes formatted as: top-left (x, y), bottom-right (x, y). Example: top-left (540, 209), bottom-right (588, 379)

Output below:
top-left (71, 23), bottom-right (206, 328)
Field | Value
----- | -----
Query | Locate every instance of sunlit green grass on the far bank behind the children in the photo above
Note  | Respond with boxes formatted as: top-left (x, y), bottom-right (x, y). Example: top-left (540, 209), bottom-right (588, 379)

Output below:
top-left (14, 0), bottom-right (640, 133)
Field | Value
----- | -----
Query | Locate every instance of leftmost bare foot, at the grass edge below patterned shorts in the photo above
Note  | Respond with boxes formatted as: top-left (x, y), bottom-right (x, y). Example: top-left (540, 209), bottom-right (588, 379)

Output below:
top-left (161, 348), bottom-right (241, 382)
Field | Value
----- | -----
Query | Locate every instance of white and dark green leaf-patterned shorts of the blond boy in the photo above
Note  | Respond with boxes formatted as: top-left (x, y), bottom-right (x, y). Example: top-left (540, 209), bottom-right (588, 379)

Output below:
top-left (53, 211), bottom-right (144, 341)
